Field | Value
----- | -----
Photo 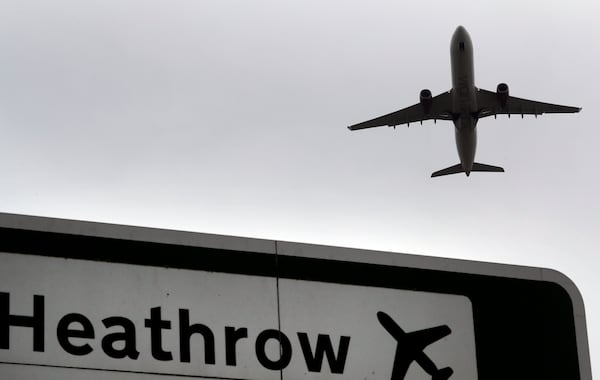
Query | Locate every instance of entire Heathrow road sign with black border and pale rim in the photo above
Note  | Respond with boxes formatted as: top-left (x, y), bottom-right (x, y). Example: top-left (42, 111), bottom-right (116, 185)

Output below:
top-left (0, 214), bottom-right (591, 380)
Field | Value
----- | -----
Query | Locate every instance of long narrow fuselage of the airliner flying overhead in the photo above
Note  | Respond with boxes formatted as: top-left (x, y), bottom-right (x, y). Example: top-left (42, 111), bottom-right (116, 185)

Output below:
top-left (450, 26), bottom-right (478, 175)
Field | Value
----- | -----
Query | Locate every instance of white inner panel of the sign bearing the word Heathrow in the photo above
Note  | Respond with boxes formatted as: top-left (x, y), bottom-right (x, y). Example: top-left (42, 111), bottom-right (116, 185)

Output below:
top-left (0, 253), bottom-right (477, 379)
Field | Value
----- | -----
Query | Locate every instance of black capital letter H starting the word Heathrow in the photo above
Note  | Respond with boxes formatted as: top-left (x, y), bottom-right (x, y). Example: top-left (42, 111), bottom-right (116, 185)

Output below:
top-left (0, 292), bottom-right (44, 352)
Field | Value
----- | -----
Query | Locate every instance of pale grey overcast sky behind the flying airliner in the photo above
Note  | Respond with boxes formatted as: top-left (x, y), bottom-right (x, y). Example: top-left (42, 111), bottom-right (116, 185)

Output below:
top-left (0, 0), bottom-right (600, 373)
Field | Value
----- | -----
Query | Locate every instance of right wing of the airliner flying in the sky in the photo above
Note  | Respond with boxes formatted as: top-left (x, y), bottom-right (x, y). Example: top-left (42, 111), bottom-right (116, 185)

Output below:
top-left (477, 89), bottom-right (581, 118)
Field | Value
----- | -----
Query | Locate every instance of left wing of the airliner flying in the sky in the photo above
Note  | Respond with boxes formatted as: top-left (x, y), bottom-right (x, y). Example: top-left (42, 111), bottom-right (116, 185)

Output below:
top-left (348, 91), bottom-right (452, 131)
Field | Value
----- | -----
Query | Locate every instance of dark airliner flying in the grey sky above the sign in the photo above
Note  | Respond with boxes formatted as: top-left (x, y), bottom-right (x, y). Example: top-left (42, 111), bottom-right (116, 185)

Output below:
top-left (348, 26), bottom-right (581, 177)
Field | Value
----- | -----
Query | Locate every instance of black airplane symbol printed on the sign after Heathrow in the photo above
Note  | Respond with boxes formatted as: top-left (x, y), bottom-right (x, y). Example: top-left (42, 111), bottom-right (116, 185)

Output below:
top-left (377, 311), bottom-right (454, 380)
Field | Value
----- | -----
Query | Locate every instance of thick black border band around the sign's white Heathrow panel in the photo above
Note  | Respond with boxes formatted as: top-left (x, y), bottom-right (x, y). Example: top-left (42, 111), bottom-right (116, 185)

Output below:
top-left (0, 228), bottom-right (580, 380)
